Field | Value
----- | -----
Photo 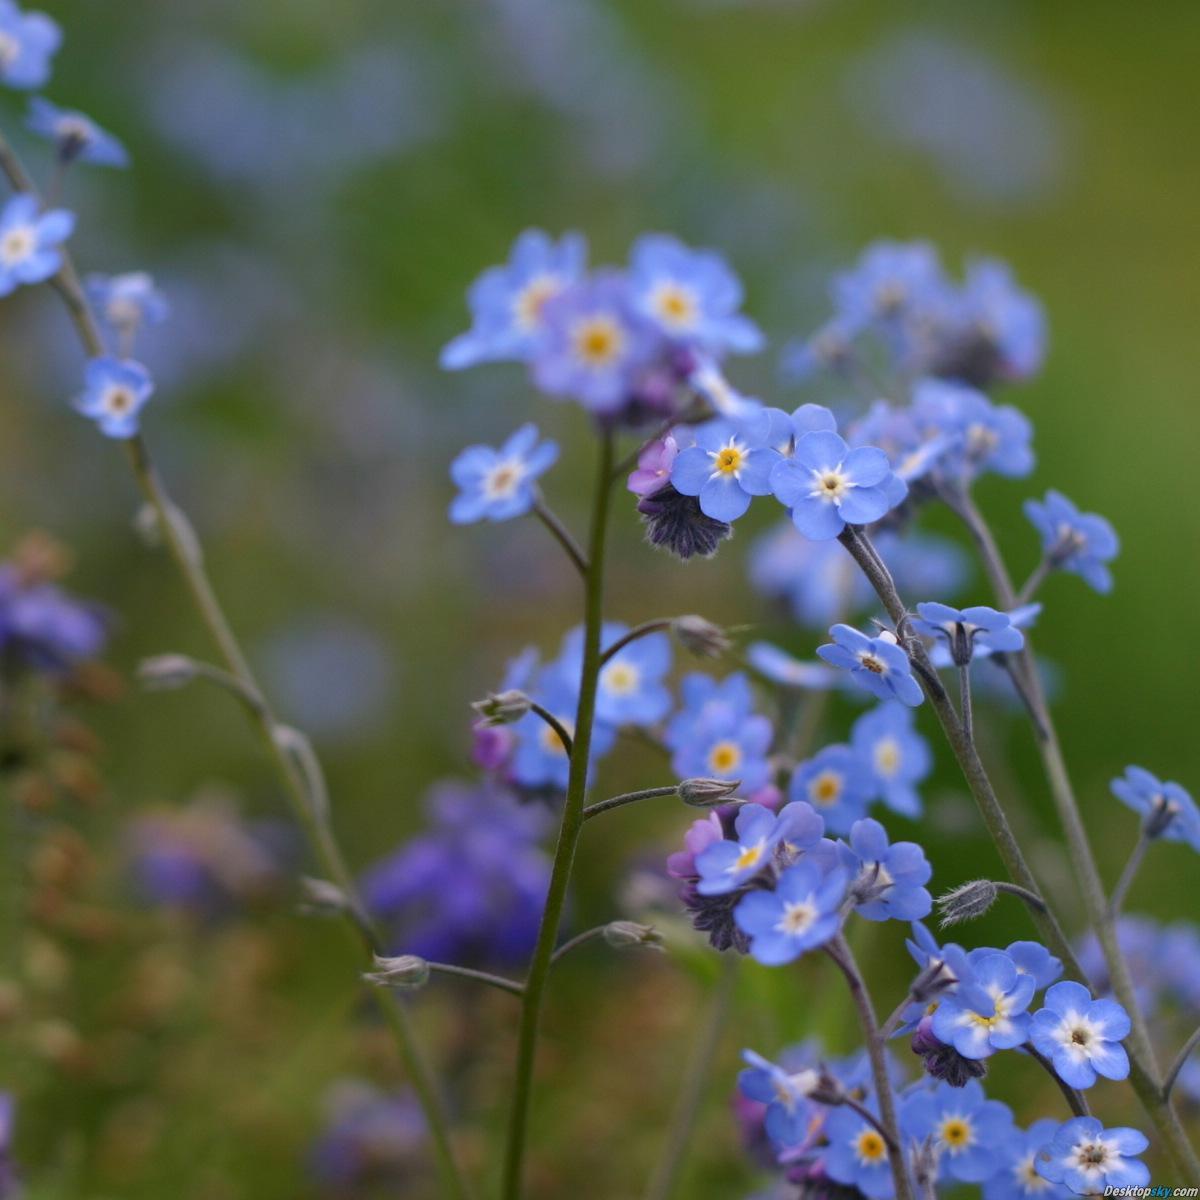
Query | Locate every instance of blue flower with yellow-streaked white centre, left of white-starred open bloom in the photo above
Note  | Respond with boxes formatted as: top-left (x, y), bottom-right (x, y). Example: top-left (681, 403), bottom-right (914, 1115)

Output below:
top-left (932, 950), bottom-right (1034, 1058)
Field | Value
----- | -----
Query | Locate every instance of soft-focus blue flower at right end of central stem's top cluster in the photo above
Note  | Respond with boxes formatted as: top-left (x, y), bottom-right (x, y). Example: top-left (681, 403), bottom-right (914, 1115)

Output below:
top-left (629, 234), bottom-right (763, 354)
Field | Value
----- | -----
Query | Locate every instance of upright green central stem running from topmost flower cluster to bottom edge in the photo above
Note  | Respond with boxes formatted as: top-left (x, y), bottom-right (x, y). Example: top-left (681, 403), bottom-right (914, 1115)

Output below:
top-left (503, 430), bottom-right (613, 1200)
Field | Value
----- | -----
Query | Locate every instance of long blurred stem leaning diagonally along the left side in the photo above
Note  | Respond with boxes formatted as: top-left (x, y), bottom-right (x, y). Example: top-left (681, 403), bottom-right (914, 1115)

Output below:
top-left (0, 126), bottom-right (474, 1200)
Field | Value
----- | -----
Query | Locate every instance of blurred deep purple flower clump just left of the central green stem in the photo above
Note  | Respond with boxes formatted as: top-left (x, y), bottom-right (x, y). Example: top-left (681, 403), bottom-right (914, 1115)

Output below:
top-left (362, 781), bottom-right (550, 965)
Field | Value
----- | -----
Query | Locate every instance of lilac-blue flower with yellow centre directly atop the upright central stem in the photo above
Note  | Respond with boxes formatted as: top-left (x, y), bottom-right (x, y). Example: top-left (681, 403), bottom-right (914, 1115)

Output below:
top-left (533, 271), bottom-right (659, 414)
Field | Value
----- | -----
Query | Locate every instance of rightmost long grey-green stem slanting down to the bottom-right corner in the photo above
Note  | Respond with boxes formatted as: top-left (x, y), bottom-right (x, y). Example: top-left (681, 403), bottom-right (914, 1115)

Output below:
top-left (943, 487), bottom-right (1200, 1180)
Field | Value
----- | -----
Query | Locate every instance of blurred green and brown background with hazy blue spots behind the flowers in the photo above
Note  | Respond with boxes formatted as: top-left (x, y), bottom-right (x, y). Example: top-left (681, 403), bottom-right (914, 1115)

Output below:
top-left (0, 0), bottom-right (1200, 1200)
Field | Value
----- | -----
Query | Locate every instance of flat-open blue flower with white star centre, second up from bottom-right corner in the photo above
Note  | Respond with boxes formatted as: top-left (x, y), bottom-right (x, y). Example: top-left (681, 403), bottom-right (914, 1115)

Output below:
top-left (1030, 979), bottom-right (1130, 1087)
